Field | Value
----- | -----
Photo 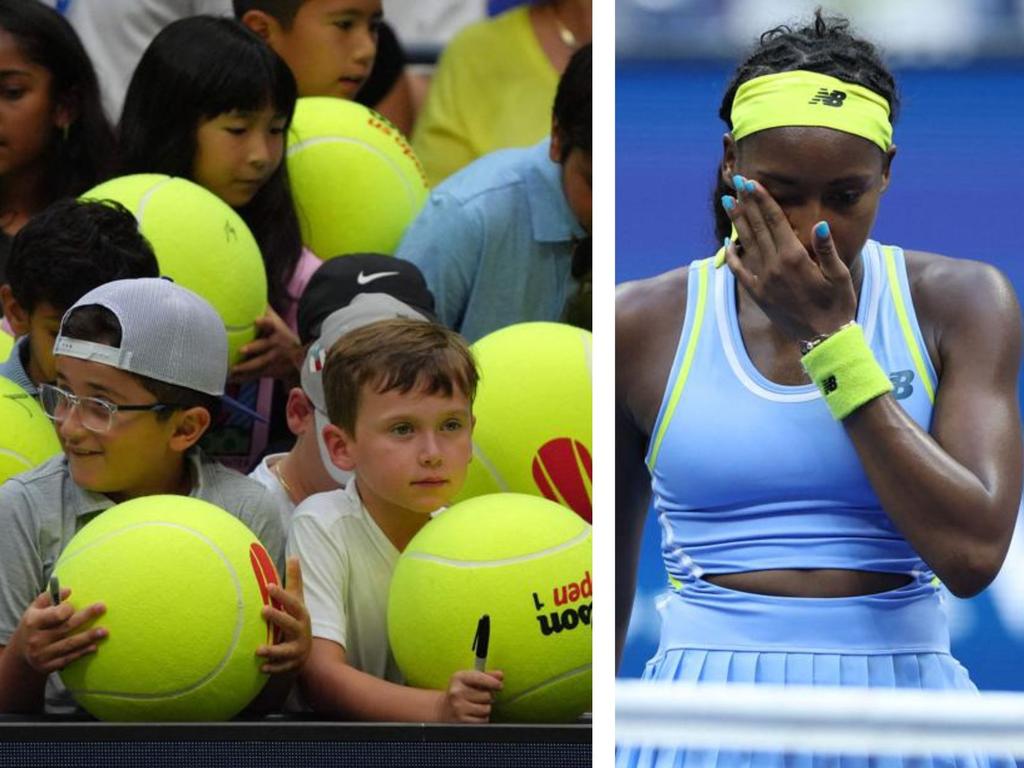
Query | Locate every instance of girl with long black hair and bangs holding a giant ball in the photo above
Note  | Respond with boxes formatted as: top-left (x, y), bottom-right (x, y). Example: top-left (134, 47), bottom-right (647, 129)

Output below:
top-left (114, 16), bottom-right (321, 472)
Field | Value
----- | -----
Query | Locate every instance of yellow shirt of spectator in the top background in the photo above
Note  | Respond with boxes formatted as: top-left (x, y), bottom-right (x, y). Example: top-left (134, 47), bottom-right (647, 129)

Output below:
top-left (413, 5), bottom-right (559, 184)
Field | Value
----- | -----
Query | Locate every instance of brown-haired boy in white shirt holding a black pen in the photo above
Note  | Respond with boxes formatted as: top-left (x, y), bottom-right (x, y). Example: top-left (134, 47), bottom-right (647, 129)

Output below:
top-left (288, 318), bottom-right (503, 722)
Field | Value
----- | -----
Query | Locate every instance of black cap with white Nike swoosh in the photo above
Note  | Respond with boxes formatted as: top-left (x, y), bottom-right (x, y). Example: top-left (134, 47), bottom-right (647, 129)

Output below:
top-left (298, 253), bottom-right (436, 344)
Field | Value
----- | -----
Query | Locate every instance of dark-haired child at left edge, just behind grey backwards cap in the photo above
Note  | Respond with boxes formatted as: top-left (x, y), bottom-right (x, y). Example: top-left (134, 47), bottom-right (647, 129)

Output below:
top-left (0, 200), bottom-right (160, 395)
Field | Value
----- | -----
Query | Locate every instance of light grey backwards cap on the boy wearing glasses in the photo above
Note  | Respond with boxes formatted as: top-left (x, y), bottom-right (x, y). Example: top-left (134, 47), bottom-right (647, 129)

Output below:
top-left (53, 278), bottom-right (227, 397)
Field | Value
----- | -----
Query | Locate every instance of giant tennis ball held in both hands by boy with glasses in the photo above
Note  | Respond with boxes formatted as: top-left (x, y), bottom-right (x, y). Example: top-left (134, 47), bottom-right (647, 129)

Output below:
top-left (54, 496), bottom-right (278, 720)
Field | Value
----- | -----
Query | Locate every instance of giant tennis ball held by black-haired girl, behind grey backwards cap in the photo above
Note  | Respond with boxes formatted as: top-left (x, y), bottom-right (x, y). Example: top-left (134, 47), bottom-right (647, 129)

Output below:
top-left (82, 173), bottom-right (266, 365)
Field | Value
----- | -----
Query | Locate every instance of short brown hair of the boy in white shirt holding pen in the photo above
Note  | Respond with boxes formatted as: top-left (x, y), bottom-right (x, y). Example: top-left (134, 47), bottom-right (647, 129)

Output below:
top-left (324, 317), bottom-right (478, 434)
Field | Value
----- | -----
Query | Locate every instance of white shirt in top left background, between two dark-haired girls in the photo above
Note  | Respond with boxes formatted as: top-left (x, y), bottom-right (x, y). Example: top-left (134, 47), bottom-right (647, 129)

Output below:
top-left (46, 0), bottom-right (234, 124)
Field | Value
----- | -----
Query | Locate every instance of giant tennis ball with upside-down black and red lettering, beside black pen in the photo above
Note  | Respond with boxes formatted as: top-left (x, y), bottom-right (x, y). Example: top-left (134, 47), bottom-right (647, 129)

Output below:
top-left (387, 494), bottom-right (593, 722)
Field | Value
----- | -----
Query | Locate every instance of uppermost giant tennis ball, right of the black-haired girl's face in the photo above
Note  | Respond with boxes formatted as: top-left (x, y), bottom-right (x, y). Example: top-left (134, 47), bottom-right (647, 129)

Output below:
top-left (288, 96), bottom-right (427, 259)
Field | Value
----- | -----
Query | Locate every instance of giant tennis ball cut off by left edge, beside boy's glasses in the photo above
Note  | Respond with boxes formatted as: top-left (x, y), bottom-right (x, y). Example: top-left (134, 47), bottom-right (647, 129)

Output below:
top-left (0, 376), bottom-right (60, 482)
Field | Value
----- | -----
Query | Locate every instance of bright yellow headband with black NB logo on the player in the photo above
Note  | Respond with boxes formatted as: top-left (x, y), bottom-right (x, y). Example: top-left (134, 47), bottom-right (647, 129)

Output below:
top-left (732, 70), bottom-right (893, 152)
